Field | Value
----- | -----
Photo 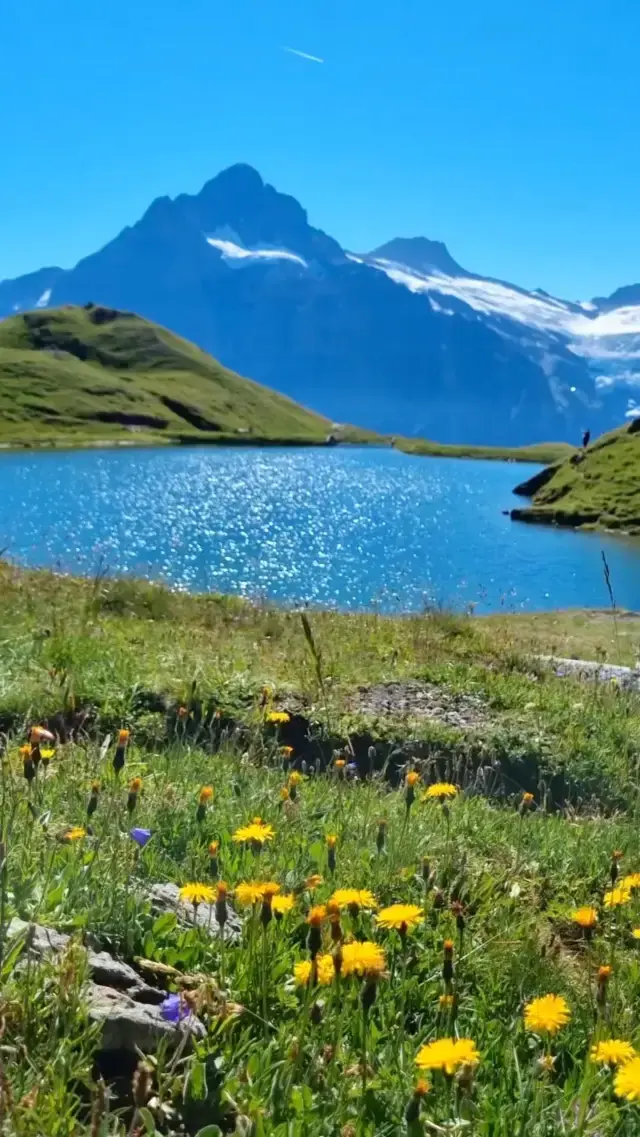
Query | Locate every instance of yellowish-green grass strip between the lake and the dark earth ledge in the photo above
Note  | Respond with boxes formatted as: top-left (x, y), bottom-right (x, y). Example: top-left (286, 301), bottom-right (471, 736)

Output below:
top-left (5, 566), bottom-right (640, 766)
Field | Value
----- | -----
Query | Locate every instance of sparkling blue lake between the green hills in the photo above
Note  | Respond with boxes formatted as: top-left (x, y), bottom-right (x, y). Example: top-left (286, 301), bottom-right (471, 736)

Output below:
top-left (0, 447), bottom-right (640, 612)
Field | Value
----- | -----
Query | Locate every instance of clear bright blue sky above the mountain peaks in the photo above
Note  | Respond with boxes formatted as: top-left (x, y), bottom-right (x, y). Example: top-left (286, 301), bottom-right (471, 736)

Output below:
top-left (0, 0), bottom-right (640, 298)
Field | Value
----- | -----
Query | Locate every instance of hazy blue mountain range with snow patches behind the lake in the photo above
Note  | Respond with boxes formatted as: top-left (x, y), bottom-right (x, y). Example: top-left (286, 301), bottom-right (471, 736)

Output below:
top-left (0, 165), bottom-right (640, 445)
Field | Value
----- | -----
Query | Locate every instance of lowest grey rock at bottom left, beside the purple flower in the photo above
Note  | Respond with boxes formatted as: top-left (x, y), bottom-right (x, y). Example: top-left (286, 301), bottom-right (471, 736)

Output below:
top-left (89, 984), bottom-right (206, 1054)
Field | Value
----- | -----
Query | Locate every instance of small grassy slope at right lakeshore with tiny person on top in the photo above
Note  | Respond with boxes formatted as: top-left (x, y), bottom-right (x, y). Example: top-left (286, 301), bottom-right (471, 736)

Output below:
top-left (512, 420), bottom-right (640, 532)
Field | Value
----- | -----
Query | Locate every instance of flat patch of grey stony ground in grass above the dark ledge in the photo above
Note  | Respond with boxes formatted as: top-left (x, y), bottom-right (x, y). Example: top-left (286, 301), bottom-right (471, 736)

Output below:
top-left (347, 680), bottom-right (489, 730)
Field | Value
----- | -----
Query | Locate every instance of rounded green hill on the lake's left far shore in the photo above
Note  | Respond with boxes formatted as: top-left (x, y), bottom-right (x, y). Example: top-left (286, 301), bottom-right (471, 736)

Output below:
top-left (0, 305), bottom-right (341, 445)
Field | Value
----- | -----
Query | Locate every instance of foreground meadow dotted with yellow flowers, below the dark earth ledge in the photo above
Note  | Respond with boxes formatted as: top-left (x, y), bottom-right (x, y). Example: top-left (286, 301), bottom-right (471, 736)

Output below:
top-left (0, 563), bottom-right (640, 1137)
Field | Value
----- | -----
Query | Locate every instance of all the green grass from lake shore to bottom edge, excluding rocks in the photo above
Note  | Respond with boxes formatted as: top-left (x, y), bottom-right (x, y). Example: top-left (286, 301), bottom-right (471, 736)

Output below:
top-left (0, 566), bottom-right (640, 1137)
